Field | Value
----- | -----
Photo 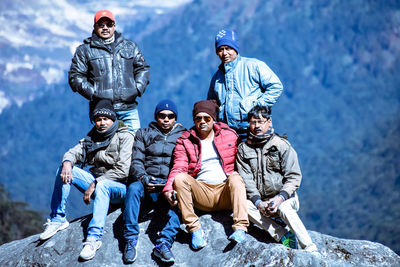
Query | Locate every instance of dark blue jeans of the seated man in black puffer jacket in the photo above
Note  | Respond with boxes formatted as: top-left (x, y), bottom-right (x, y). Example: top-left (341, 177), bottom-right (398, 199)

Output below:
top-left (124, 181), bottom-right (180, 245)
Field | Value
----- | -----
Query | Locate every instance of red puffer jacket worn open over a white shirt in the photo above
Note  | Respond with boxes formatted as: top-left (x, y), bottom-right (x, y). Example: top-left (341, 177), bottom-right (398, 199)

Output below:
top-left (163, 122), bottom-right (238, 192)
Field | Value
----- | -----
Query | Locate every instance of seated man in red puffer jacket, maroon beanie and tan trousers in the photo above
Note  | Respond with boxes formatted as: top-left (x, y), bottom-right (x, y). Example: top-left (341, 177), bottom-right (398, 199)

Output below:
top-left (163, 100), bottom-right (249, 249)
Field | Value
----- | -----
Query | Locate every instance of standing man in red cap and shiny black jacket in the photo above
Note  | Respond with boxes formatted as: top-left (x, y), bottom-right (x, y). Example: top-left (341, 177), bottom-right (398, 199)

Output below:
top-left (68, 10), bottom-right (150, 132)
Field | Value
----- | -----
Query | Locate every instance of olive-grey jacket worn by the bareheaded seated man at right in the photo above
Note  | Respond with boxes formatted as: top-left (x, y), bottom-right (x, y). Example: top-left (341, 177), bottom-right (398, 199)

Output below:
top-left (236, 134), bottom-right (302, 206)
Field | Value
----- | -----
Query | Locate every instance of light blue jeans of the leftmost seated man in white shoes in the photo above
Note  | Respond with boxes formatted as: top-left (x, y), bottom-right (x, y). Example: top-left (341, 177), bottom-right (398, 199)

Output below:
top-left (50, 167), bottom-right (126, 240)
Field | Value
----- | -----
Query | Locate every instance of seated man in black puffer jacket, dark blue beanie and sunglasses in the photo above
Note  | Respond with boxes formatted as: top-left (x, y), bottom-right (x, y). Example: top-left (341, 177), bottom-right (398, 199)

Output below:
top-left (124, 100), bottom-right (186, 263)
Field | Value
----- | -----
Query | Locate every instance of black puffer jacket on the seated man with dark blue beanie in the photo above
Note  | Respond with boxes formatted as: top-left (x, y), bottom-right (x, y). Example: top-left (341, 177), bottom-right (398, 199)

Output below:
top-left (129, 122), bottom-right (186, 181)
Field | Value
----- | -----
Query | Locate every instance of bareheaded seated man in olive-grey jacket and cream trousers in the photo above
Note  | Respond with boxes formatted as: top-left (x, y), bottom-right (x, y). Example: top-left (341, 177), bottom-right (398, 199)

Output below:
top-left (236, 105), bottom-right (318, 253)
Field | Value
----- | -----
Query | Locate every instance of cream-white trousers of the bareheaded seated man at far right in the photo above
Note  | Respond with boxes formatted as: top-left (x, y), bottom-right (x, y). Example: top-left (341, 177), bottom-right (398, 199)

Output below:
top-left (247, 194), bottom-right (313, 249)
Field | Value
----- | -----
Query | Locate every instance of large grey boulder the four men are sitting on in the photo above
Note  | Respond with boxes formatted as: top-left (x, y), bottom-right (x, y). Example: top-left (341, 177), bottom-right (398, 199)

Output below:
top-left (0, 209), bottom-right (400, 267)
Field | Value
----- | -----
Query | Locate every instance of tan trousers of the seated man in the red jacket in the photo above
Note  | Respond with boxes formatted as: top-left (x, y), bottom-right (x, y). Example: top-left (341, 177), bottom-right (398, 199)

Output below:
top-left (174, 173), bottom-right (249, 232)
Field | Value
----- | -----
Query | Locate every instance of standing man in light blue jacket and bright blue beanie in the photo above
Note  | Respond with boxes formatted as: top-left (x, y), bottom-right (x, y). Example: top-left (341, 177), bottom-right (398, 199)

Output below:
top-left (207, 30), bottom-right (283, 138)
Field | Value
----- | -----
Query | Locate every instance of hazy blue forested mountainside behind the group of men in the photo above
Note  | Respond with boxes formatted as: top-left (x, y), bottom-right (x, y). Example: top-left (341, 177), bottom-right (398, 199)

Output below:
top-left (0, 0), bottom-right (400, 253)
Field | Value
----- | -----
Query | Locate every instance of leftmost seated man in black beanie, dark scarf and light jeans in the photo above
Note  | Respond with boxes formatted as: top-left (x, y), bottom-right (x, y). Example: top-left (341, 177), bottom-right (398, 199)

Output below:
top-left (39, 99), bottom-right (134, 260)
